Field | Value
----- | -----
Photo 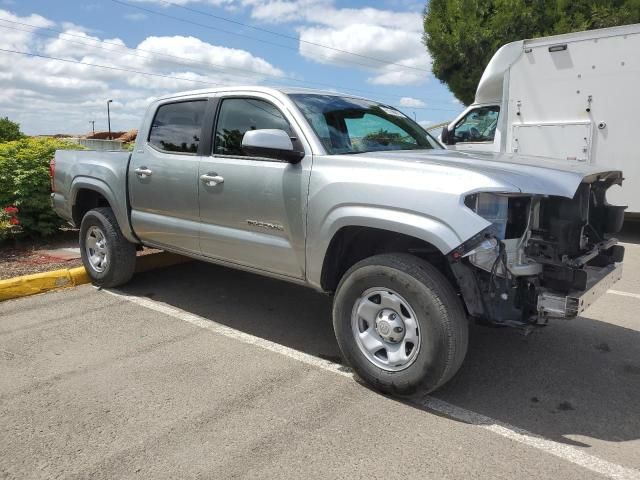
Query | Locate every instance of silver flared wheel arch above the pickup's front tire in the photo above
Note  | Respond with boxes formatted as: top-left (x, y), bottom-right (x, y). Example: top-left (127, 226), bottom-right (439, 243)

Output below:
top-left (307, 205), bottom-right (463, 289)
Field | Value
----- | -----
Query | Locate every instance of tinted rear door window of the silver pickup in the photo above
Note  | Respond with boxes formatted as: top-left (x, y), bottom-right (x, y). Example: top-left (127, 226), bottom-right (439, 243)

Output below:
top-left (149, 100), bottom-right (207, 154)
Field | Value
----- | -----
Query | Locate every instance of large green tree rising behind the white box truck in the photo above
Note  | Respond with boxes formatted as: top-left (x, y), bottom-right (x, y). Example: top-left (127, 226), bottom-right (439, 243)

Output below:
top-left (423, 0), bottom-right (640, 105)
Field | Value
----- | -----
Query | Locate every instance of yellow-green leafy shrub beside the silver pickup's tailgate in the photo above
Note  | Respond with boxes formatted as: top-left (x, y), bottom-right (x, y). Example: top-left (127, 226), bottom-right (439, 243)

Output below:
top-left (0, 138), bottom-right (80, 237)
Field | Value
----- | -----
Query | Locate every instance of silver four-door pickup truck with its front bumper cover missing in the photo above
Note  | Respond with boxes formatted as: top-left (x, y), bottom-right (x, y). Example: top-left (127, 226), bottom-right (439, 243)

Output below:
top-left (52, 87), bottom-right (625, 393)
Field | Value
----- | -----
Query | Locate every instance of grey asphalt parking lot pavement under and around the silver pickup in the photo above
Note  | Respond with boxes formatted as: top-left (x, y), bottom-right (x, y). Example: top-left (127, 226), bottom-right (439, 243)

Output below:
top-left (0, 229), bottom-right (640, 479)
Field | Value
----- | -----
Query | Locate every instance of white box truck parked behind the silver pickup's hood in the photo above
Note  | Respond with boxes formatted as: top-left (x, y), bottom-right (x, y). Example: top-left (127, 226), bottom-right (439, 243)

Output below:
top-left (441, 24), bottom-right (640, 217)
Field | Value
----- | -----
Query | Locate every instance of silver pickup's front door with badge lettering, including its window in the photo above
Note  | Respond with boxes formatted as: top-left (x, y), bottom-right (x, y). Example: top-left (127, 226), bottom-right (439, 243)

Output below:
top-left (199, 94), bottom-right (311, 278)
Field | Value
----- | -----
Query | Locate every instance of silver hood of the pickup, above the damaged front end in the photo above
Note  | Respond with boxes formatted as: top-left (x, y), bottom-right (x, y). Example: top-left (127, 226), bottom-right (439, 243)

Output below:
top-left (349, 149), bottom-right (622, 198)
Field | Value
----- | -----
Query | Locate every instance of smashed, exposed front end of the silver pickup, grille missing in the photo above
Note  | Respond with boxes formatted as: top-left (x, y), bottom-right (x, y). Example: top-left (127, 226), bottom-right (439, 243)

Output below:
top-left (449, 172), bottom-right (626, 326)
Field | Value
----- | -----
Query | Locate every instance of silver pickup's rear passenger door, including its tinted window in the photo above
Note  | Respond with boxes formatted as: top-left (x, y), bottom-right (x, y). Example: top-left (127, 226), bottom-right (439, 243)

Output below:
top-left (129, 99), bottom-right (210, 253)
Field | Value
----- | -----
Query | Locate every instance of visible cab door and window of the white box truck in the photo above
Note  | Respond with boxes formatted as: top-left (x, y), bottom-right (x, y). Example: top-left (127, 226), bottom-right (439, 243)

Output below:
top-left (447, 105), bottom-right (500, 152)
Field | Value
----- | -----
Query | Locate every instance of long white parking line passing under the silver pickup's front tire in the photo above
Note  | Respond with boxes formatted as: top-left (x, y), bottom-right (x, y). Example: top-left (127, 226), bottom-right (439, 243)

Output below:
top-left (102, 290), bottom-right (640, 480)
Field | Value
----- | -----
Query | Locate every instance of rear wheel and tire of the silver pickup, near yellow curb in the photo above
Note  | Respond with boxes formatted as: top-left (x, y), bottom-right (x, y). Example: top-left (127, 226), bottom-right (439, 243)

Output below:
top-left (80, 207), bottom-right (136, 287)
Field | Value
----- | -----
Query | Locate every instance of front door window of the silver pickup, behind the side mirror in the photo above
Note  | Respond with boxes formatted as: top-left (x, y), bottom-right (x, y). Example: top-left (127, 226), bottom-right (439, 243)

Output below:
top-left (214, 98), bottom-right (293, 156)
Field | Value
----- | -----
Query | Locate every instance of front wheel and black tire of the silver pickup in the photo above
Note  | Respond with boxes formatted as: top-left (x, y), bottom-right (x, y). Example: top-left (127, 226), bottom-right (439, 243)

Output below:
top-left (333, 253), bottom-right (469, 395)
